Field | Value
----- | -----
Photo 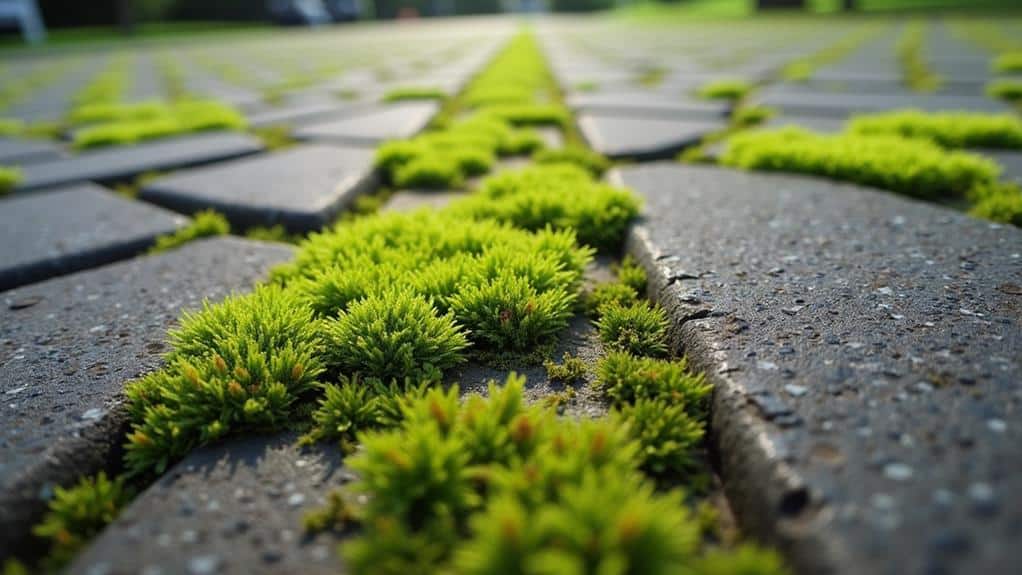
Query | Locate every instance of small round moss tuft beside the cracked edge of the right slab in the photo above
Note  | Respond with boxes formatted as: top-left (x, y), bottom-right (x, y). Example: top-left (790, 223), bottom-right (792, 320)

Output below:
top-left (596, 302), bottom-right (667, 357)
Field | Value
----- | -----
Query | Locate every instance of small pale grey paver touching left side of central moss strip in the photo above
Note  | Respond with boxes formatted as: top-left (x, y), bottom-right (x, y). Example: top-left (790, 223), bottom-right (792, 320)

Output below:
top-left (295, 102), bottom-right (439, 146)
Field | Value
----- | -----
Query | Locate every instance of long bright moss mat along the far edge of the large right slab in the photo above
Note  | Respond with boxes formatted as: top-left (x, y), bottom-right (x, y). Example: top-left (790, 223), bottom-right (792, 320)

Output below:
top-left (721, 128), bottom-right (1001, 199)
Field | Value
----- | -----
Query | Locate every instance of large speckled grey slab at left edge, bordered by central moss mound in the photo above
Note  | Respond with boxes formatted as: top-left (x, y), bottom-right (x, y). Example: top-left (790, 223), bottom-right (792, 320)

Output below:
top-left (0, 238), bottom-right (291, 550)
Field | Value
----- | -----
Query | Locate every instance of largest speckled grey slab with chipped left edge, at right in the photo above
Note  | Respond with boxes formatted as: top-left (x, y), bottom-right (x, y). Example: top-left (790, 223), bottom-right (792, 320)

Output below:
top-left (612, 163), bottom-right (1022, 574)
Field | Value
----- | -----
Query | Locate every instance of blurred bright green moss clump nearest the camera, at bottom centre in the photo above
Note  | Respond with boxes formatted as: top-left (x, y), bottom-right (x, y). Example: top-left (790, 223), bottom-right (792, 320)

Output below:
top-left (343, 376), bottom-right (711, 573)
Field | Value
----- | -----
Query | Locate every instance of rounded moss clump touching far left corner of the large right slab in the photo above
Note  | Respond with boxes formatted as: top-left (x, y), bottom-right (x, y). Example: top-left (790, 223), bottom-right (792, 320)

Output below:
top-left (448, 164), bottom-right (640, 251)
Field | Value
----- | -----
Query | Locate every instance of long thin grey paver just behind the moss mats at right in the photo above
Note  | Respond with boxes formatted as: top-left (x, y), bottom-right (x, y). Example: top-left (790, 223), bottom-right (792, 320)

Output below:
top-left (754, 88), bottom-right (1012, 117)
